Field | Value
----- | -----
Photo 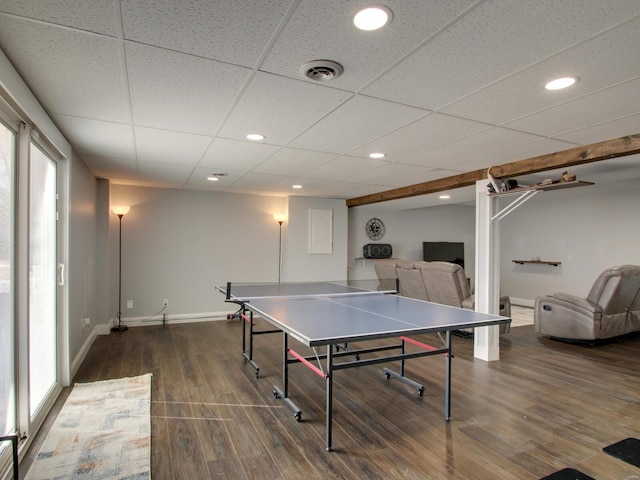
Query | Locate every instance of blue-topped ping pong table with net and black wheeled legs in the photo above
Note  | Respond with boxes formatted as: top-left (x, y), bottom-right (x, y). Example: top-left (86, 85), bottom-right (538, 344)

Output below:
top-left (216, 282), bottom-right (511, 451)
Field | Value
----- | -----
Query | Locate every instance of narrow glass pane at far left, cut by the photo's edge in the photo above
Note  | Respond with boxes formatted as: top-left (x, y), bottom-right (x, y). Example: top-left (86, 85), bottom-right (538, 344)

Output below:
top-left (0, 123), bottom-right (16, 435)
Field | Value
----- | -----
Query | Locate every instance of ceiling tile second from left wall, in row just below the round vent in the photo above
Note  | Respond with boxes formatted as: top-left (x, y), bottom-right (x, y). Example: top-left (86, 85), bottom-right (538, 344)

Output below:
top-left (126, 44), bottom-right (251, 135)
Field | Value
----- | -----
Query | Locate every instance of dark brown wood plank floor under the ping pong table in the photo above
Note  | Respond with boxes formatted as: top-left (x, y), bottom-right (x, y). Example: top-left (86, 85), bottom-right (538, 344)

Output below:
top-left (21, 320), bottom-right (640, 480)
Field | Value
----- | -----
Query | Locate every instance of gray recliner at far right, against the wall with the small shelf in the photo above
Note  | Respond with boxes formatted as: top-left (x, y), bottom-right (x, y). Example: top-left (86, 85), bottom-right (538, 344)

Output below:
top-left (534, 265), bottom-right (640, 341)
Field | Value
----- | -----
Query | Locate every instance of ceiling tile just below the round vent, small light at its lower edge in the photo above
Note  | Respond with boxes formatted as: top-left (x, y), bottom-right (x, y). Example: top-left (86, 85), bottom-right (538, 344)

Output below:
top-left (220, 72), bottom-right (352, 145)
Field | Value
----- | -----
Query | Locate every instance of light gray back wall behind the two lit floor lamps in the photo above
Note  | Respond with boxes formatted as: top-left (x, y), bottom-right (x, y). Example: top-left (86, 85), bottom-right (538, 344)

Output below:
top-left (110, 185), bottom-right (347, 321)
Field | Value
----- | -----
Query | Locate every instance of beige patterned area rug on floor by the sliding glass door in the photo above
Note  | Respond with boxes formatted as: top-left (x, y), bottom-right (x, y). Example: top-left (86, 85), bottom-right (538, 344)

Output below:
top-left (25, 374), bottom-right (151, 480)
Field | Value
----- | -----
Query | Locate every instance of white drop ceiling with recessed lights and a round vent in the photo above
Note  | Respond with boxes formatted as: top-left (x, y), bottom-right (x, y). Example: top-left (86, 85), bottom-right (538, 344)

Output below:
top-left (0, 0), bottom-right (640, 209)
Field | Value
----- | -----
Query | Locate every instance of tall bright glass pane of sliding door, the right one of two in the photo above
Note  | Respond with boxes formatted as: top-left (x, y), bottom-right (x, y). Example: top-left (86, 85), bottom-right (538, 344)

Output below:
top-left (29, 144), bottom-right (57, 416)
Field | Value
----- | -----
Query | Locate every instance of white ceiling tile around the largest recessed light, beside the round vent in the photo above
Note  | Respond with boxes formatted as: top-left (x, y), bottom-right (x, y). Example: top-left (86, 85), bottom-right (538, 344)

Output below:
top-left (261, 0), bottom-right (473, 92)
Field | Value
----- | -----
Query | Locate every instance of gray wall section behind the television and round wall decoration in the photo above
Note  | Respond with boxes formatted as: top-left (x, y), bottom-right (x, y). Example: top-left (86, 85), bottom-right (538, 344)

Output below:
top-left (348, 205), bottom-right (475, 280)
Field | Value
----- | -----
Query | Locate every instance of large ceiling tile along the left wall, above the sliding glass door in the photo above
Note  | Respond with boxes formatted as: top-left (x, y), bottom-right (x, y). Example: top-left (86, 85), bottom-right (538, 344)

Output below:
top-left (0, 15), bottom-right (130, 122)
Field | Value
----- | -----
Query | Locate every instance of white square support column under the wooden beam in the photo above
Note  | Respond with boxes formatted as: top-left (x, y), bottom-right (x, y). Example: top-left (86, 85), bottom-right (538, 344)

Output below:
top-left (473, 180), bottom-right (500, 362)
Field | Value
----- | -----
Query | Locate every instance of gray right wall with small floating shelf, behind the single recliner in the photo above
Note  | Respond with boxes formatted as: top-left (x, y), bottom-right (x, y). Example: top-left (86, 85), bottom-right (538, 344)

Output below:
top-left (500, 180), bottom-right (640, 305)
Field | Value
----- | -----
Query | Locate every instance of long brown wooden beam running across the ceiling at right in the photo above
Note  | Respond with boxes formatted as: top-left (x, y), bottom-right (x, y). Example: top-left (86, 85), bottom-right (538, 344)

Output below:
top-left (347, 133), bottom-right (640, 207)
